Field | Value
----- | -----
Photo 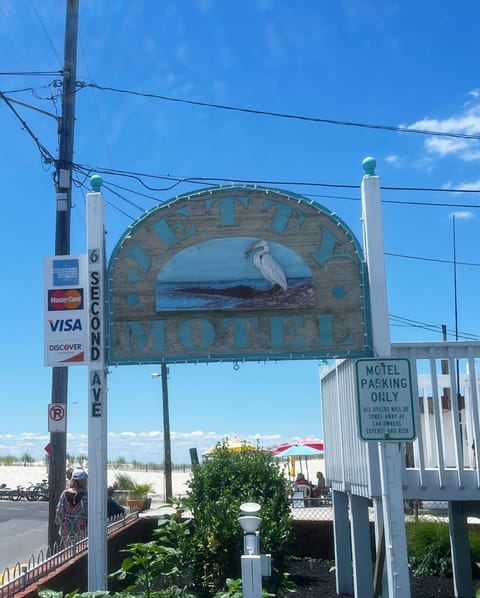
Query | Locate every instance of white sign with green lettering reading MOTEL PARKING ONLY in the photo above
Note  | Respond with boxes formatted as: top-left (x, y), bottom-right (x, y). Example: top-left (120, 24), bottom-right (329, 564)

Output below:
top-left (356, 359), bottom-right (415, 442)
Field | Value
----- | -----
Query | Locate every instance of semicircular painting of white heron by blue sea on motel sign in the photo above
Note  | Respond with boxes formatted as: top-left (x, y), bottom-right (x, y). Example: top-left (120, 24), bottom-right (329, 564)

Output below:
top-left (156, 237), bottom-right (315, 312)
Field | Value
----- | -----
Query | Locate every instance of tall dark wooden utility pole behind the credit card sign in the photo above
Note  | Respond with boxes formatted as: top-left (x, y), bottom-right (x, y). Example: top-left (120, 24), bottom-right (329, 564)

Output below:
top-left (48, 0), bottom-right (79, 547)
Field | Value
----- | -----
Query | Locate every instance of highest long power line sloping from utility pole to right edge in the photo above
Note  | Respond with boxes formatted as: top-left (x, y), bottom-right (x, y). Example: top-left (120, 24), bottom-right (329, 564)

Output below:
top-left (86, 83), bottom-right (480, 141)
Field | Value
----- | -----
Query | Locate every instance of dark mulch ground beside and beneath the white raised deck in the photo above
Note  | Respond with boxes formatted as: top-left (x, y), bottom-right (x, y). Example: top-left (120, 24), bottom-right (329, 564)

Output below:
top-left (286, 559), bottom-right (462, 598)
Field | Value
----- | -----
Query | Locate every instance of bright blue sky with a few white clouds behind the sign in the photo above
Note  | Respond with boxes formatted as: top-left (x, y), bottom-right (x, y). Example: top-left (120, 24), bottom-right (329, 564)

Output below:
top-left (0, 0), bottom-right (480, 462)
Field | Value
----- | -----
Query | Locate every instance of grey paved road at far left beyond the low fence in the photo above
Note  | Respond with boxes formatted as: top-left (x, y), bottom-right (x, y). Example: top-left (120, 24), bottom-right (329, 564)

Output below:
top-left (0, 500), bottom-right (48, 573)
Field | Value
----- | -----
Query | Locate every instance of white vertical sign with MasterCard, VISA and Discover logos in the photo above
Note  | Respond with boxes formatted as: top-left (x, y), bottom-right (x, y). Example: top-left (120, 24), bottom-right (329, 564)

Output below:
top-left (44, 255), bottom-right (88, 366)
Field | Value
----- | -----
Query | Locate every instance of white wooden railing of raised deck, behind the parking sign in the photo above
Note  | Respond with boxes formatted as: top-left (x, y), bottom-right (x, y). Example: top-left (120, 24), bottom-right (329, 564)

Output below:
top-left (320, 341), bottom-right (480, 500)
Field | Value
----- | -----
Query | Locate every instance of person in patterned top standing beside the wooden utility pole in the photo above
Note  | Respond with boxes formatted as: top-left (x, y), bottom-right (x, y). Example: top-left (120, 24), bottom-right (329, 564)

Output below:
top-left (55, 467), bottom-right (88, 546)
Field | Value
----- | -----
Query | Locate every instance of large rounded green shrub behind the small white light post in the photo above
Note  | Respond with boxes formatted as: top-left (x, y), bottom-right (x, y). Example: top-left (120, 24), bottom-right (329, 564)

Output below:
top-left (182, 444), bottom-right (292, 596)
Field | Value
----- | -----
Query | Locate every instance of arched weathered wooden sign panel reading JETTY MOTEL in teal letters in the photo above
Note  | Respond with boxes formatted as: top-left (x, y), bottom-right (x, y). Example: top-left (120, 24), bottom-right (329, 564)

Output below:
top-left (108, 187), bottom-right (371, 364)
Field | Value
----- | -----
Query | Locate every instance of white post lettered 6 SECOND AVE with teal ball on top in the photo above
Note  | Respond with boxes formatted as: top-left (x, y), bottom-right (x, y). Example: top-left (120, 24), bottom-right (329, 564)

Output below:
top-left (87, 176), bottom-right (107, 592)
